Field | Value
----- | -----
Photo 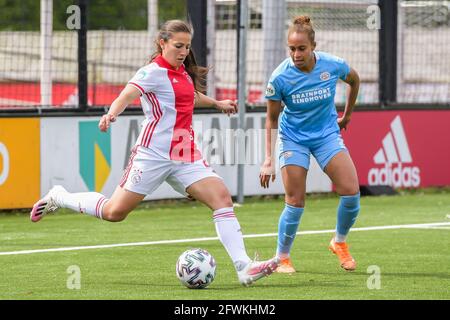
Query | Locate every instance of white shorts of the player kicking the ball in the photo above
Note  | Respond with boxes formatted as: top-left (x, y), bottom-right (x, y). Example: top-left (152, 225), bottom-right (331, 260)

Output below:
top-left (120, 146), bottom-right (222, 196)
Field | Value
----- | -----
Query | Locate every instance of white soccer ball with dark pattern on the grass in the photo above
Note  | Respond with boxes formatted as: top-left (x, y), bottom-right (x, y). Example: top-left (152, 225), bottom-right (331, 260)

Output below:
top-left (176, 248), bottom-right (216, 289)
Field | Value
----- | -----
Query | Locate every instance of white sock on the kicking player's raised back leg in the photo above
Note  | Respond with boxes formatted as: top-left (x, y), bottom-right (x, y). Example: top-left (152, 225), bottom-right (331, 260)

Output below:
top-left (55, 192), bottom-right (109, 219)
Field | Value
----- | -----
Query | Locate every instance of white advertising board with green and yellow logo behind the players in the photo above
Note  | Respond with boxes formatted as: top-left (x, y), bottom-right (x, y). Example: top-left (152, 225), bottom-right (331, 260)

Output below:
top-left (41, 113), bottom-right (331, 200)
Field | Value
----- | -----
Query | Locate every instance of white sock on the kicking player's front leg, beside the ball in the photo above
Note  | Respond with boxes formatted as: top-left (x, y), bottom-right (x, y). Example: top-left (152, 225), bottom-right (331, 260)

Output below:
top-left (213, 208), bottom-right (251, 271)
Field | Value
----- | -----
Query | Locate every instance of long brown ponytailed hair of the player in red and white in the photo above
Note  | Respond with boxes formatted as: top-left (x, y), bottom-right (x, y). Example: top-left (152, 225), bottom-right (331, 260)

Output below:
top-left (150, 20), bottom-right (209, 93)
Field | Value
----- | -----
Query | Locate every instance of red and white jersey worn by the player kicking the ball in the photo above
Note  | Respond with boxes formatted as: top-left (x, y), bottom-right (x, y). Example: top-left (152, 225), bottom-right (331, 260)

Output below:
top-left (128, 56), bottom-right (202, 162)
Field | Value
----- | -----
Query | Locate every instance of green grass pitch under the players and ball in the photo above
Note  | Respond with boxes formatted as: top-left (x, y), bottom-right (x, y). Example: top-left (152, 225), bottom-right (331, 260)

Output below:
top-left (0, 189), bottom-right (450, 300)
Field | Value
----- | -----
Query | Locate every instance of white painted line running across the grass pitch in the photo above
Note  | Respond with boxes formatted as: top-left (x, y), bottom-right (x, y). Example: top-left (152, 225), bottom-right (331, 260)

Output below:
top-left (0, 222), bottom-right (450, 256)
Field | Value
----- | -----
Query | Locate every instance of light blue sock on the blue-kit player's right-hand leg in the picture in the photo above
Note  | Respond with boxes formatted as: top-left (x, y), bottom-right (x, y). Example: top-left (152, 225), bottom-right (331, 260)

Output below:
top-left (336, 193), bottom-right (360, 242)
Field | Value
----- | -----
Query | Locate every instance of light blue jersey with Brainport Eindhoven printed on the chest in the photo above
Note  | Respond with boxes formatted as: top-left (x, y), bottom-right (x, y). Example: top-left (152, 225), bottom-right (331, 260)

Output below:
top-left (266, 51), bottom-right (350, 146)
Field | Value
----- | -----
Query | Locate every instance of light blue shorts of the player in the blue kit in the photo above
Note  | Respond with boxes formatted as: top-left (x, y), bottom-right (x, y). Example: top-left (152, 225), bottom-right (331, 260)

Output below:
top-left (279, 133), bottom-right (348, 170)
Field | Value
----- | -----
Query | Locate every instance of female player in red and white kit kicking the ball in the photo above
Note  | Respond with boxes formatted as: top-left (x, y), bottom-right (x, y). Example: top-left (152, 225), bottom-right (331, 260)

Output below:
top-left (30, 20), bottom-right (278, 285)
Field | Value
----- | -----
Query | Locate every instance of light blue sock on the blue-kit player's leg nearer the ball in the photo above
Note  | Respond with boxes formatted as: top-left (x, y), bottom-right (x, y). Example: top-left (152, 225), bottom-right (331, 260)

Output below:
top-left (277, 204), bottom-right (303, 255)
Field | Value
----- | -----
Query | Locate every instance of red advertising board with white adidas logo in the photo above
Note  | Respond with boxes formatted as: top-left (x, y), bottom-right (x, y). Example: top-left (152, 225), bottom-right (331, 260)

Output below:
top-left (342, 110), bottom-right (450, 188)
